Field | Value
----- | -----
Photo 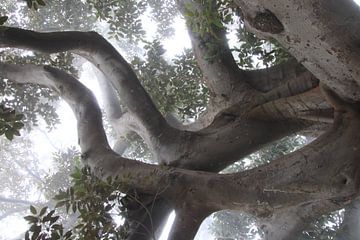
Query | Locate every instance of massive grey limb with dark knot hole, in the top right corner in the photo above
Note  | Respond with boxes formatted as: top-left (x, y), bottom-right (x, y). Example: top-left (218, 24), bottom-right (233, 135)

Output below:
top-left (235, 0), bottom-right (360, 100)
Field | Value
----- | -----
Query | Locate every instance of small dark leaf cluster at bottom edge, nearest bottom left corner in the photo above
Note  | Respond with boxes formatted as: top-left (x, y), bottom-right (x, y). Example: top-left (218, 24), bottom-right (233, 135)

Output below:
top-left (24, 206), bottom-right (72, 240)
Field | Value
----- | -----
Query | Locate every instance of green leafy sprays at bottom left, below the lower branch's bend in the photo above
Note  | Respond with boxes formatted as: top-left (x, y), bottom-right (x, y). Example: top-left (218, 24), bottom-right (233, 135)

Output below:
top-left (25, 167), bottom-right (128, 240)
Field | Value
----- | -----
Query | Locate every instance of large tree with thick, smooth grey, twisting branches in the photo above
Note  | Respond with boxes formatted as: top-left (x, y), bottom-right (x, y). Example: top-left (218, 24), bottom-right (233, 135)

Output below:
top-left (0, 0), bottom-right (360, 239)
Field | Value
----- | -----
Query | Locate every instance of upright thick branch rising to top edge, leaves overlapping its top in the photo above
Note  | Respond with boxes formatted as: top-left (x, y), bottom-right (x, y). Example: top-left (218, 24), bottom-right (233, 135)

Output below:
top-left (178, 0), bottom-right (260, 131)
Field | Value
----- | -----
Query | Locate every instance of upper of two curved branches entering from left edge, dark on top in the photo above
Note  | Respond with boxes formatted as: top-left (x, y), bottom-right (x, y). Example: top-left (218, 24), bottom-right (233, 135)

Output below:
top-left (0, 27), bottom-right (168, 136)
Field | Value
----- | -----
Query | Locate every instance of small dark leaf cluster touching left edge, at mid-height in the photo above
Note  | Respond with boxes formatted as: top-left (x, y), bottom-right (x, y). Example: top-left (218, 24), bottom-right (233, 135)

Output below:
top-left (0, 104), bottom-right (24, 140)
